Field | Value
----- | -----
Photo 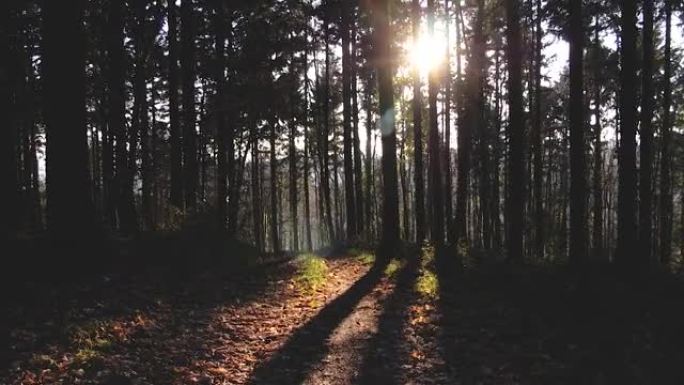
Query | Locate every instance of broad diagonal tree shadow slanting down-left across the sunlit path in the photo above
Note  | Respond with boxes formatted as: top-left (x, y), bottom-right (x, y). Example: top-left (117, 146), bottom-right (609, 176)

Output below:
top-left (248, 261), bottom-right (387, 385)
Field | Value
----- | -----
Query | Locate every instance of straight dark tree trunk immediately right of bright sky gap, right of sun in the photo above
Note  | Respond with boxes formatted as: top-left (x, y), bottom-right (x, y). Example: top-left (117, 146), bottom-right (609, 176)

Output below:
top-left (569, 0), bottom-right (588, 266)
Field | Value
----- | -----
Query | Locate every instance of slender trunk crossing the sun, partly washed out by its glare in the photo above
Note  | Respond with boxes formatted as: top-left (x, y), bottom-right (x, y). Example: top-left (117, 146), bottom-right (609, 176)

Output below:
top-left (427, 0), bottom-right (444, 246)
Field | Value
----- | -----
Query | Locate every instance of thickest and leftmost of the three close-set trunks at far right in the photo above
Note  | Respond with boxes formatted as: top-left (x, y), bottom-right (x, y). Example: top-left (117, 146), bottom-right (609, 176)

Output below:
top-left (616, 1), bottom-right (639, 268)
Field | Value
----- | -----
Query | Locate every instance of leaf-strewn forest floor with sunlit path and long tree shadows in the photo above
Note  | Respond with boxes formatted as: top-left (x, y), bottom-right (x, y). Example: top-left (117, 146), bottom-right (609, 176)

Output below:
top-left (0, 246), bottom-right (684, 385)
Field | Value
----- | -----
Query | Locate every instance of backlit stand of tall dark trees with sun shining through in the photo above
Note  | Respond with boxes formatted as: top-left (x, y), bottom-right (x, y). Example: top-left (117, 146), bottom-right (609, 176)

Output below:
top-left (0, 0), bottom-right (684, 268)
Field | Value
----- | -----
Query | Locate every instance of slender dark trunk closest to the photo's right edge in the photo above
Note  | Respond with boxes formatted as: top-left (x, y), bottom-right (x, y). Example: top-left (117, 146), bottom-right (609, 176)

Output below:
top-left (659, 0), bottom-right (672, 268)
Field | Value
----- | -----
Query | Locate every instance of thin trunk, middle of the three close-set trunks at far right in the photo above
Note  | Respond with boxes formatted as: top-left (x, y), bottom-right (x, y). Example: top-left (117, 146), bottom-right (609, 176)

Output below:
top-left (639, 0), bottom-right (654, 262)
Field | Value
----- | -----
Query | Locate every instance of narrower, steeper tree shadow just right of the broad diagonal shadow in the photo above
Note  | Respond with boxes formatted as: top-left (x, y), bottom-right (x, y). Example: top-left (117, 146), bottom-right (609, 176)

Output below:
top-left (358, 257), bottom-right (420, 385)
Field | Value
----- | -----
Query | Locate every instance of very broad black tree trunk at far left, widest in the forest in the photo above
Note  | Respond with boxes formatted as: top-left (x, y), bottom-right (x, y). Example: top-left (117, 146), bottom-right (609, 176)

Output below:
top-left (42, 0), bottom-right (95, 240)
